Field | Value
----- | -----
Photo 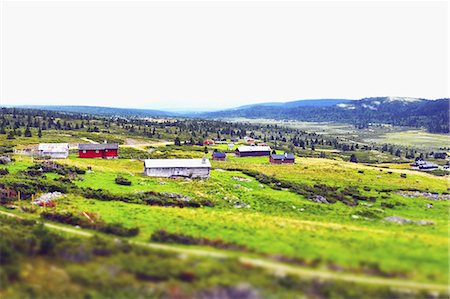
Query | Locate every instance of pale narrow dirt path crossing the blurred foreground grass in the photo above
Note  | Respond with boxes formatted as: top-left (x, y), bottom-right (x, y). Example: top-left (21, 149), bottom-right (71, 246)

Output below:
top-left (0, 211), bottom-right (450, 292)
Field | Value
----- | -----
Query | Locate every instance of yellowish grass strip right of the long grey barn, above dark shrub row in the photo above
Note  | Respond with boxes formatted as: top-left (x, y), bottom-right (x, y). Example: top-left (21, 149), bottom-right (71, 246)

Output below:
top-left (219, 157), bottom-right (448, 192)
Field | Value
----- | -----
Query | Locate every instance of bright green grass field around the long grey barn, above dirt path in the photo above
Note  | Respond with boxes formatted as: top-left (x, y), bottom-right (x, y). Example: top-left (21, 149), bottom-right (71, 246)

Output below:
top-left (2, 153), bottom-right (449, 284)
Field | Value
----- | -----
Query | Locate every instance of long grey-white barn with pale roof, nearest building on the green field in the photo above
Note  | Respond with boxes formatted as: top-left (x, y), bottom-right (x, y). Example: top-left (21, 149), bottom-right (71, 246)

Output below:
top-left (144, 157), bottom-right (211, 178)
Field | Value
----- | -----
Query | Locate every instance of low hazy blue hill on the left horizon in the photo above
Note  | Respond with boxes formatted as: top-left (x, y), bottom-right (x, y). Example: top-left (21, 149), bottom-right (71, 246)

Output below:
top-left (20, 105), bottom-right (176, 117)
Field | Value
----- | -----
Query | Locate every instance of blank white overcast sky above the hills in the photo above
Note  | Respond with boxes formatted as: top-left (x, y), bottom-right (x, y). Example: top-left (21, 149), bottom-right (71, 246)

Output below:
top-left (0, 0), bottom-right (450, 111)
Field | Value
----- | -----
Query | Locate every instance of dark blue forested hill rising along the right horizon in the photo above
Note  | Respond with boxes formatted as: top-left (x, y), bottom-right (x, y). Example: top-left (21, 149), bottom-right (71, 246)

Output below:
top-left (202, 97), bottom-right (449, 133)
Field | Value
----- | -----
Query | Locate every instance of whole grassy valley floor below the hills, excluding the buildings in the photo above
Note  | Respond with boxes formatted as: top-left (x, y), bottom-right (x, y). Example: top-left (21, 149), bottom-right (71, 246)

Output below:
top-left (0, 111), bottom-right (450, 298)
